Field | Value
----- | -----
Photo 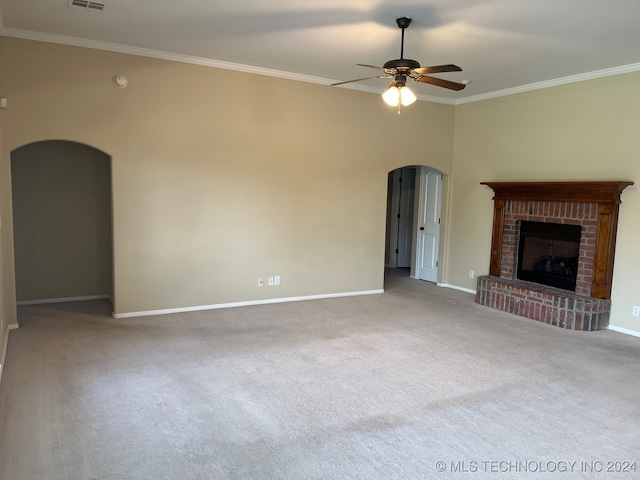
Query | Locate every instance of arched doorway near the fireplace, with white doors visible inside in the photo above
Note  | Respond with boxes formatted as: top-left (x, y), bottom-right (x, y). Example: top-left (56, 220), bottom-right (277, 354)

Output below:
top-left (385, 165), bottom-right (444, 283)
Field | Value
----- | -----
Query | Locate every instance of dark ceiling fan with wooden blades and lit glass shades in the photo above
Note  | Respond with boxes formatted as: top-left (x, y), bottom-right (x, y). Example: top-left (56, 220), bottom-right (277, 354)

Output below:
top-left (331, 17), bottom-right (466, 109)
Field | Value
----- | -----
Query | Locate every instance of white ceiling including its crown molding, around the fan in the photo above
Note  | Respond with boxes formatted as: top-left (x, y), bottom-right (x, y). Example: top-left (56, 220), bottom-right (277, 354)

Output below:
top-left (0, 0), bottom-right (640, 103)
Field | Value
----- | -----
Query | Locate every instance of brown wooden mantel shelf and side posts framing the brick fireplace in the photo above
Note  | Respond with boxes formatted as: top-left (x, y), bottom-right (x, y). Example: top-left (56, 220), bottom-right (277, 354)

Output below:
top-left (481, 181), bottom-right (633, 299)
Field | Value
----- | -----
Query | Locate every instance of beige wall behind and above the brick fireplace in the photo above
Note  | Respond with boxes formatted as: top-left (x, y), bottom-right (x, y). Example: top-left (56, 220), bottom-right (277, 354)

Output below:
top-left (447, 73), bottom-right (640, 332)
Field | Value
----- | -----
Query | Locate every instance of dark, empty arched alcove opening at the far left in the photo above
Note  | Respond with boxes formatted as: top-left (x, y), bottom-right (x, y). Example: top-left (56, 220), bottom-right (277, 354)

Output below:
top-left (11, 140), bottom-right (114, 305)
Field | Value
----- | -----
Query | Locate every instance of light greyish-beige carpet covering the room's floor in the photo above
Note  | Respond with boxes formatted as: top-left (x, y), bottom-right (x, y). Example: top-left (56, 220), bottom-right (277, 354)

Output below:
top-left (0, 271), bottom-right (640, 480)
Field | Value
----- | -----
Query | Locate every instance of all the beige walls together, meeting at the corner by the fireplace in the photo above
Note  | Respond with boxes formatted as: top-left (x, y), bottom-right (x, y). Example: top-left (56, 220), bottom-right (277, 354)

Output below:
top-left (0, 37), bottom-right (640, 331)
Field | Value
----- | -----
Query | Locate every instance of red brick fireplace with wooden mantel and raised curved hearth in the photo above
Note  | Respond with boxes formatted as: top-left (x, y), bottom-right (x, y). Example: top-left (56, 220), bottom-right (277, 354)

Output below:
top-left (476, 181), bottom-right (633, 331)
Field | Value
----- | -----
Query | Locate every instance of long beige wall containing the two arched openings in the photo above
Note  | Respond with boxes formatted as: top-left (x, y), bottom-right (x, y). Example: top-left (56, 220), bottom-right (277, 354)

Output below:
top-left (0, 37), bottom-right (454, 313)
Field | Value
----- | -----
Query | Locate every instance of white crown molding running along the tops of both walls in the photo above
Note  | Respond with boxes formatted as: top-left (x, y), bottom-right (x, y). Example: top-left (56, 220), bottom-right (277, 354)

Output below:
top-left (0, 26), bottom-right (640, 105)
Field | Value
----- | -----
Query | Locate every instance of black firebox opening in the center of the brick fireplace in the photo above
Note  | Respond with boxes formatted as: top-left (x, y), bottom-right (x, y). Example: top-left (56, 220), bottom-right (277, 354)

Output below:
top-left (516, 220), bottom-right (582, 292)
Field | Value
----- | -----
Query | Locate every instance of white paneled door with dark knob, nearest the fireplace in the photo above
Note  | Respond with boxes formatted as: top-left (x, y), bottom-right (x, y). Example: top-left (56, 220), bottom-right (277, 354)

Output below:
top-left (416, 168), bottom-right (442, 282)
